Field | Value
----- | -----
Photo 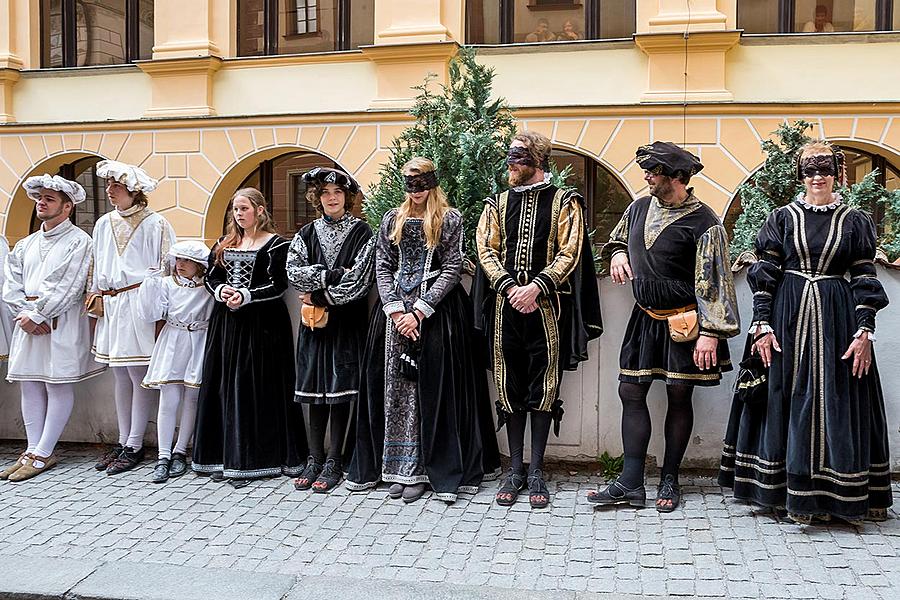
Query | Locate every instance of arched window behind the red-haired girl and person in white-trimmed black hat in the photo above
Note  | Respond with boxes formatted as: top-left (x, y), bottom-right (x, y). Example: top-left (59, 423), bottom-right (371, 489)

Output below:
top-left (225, 152), bottom-right (362, 237)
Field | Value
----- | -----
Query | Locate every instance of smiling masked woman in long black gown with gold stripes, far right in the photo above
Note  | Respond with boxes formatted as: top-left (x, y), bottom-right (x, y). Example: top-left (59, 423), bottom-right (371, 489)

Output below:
top-left (719, 143), bottom-right (891, 523)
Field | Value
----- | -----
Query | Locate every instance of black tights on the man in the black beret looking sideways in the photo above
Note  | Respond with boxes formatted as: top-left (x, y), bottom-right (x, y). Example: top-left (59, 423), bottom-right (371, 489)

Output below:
top-left (619, 382), bottom-right (694, 488)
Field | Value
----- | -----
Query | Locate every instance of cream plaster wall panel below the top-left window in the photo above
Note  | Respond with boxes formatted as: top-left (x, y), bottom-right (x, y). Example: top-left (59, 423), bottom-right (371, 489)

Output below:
top-left (13, 67), bottom-right (150, 123)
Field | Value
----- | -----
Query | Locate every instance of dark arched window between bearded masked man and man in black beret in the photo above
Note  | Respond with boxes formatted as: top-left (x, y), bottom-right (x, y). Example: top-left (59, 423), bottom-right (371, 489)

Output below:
top-left (551, 149), bottom-right (632, 244)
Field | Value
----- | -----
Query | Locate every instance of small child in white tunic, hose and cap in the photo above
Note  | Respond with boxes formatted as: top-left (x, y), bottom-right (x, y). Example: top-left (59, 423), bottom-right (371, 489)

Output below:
top-left (139, 241), bottom-right (213, 483)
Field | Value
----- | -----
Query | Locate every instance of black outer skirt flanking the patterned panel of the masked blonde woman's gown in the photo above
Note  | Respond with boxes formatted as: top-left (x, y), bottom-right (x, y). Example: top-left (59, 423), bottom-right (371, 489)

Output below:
top-left (347, 286), bottom-right (500, 501)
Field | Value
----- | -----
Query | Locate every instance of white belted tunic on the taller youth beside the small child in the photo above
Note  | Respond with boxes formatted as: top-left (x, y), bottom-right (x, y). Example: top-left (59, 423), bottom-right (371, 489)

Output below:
top-left (91, 206), bottom-right (175, 367)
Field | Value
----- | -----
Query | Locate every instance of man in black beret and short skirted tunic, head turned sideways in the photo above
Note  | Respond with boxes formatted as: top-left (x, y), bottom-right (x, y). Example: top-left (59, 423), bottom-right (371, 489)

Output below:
top-left (588, 142), bottom-right (740, 512)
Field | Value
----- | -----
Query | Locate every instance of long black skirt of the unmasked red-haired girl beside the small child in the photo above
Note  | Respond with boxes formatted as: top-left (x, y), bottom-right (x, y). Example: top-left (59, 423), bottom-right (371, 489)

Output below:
top-left (193, 298), bottom-right (307, 479)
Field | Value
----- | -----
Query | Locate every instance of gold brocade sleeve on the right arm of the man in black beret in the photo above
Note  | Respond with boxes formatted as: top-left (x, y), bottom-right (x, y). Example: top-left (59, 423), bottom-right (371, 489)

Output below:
top-left (694, 225), bottom-right (741, 339)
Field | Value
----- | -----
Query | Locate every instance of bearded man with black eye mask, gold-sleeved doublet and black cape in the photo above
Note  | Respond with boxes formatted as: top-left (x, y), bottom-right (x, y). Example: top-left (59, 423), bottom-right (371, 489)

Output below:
top-left (473, 132), bottom-right (602, 508)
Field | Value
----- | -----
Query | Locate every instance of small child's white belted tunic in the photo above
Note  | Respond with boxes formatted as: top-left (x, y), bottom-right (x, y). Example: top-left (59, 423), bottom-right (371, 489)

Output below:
top-left (138, 275), bottom-right (213, 388)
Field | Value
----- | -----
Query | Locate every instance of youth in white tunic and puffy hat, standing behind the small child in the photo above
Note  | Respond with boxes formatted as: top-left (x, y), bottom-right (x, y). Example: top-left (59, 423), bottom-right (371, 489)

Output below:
top-left (91, 160), bottom-right (175, 475)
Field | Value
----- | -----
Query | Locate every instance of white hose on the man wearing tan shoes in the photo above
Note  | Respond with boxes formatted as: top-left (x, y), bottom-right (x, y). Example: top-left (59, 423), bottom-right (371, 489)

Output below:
top-left (21, 381), bottom-right (75, 467)
